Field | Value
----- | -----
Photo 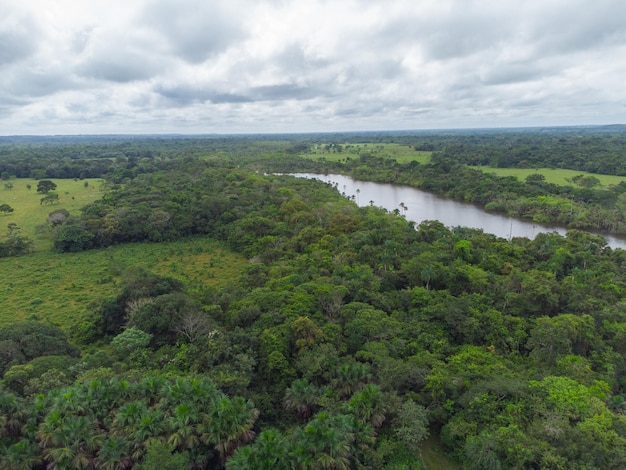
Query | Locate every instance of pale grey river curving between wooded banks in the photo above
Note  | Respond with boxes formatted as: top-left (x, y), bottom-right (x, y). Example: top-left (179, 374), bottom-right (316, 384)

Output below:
top-left (292, 173), bottom-right (626, 249)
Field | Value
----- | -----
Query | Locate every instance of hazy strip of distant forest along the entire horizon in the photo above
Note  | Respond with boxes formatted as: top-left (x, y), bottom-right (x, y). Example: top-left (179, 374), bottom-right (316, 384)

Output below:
top-left (7, 126), bottom-right (626, 178)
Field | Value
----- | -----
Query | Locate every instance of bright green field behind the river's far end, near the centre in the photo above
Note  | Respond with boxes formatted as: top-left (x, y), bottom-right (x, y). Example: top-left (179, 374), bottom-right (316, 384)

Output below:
top-left (301, 143), bottom-right (432, 163)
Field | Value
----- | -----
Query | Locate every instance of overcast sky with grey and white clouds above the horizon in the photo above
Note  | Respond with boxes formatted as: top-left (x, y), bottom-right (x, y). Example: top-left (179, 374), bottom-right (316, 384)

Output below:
top-left (0, 0), bottom-right (626, 135)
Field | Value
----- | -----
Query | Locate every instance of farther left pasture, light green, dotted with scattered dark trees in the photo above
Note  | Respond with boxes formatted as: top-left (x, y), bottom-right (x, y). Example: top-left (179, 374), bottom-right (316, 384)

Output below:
top-left (0, 178), bottom-right (103, 251)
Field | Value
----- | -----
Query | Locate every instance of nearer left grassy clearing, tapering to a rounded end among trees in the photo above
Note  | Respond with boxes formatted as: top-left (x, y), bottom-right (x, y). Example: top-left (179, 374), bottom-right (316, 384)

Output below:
top-left (0, 238), bottom-right (247, 332)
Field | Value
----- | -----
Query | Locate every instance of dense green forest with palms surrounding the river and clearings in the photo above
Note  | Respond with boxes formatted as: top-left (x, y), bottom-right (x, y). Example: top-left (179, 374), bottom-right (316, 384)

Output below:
top-left (0, 129), bottom-right (626, 470)
